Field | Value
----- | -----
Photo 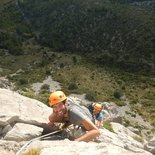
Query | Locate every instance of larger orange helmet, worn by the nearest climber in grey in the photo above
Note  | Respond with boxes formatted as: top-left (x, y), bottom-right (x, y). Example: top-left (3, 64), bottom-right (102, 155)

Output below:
top-left (49, 91), bottom-right (67, 106)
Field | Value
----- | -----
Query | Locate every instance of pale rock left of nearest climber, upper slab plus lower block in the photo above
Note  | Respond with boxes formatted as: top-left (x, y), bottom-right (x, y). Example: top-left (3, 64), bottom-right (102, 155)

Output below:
top-left (0, 89), bottom-right (52, 145)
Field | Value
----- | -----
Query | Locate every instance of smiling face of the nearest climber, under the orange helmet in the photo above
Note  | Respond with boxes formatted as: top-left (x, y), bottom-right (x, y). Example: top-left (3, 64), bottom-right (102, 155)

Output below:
top-left (53, 102), bottom-right (66, 117)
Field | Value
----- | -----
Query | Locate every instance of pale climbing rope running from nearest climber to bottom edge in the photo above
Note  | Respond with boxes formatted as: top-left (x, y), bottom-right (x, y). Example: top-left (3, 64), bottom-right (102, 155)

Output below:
top-left (16, 130), bottom-right (62, 155)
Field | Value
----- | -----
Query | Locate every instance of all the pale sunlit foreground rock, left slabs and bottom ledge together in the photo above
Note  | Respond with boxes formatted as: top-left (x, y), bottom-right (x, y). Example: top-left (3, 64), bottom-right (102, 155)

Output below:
top-left (0, 89), bottom-right (154, 155)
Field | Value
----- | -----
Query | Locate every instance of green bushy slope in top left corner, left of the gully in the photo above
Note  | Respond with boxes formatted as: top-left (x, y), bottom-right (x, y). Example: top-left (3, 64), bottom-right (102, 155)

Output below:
top-left (0, 0), bottom-right (32, 55)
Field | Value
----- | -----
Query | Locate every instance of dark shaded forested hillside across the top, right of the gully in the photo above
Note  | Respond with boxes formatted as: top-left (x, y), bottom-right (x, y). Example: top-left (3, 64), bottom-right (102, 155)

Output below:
top-left (17, 0), bottom-right (155, 73)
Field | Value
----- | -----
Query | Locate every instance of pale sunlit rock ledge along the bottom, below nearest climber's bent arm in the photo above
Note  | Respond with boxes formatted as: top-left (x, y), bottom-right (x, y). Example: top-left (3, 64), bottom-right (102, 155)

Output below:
top-left (23, 127), bottom-right (151, 155)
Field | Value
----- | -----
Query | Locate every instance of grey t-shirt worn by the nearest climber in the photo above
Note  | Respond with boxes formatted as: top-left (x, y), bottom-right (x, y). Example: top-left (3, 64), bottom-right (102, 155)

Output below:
top-left (67, 98), bottom-right (94, 126)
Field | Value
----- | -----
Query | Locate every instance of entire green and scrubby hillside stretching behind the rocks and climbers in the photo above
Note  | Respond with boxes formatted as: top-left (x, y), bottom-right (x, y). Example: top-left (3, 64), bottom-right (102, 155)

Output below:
top-left (0, 0), bottom-right (155, 130)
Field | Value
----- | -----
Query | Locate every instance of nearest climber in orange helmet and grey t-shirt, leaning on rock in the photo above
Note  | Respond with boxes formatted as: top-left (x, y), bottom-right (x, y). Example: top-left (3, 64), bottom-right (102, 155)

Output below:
top-left (48, 91), bottom-right (100, 142)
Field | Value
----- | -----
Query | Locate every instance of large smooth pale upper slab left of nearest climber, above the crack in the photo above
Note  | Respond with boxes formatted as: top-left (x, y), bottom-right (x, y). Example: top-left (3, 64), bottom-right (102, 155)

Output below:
top-left (0, 89), bottom-right (52, 127)
